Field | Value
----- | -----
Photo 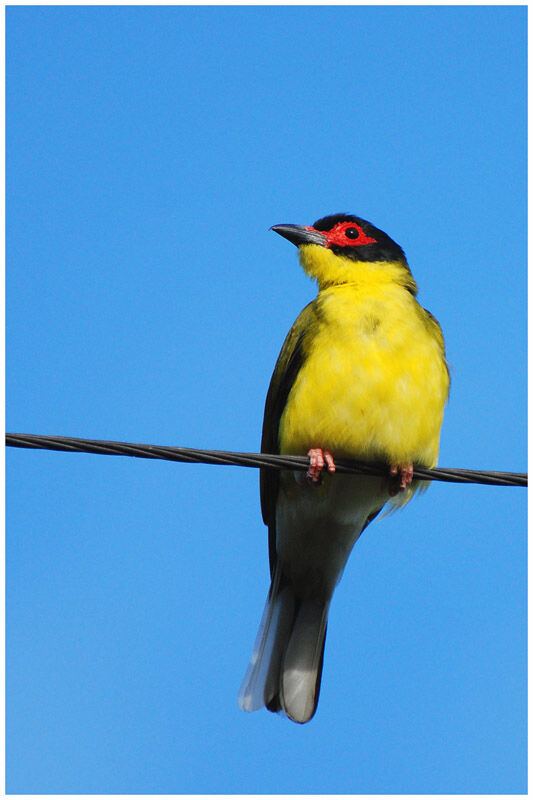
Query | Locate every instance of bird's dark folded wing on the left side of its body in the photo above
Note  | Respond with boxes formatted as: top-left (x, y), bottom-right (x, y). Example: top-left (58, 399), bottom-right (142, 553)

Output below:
top-left (260, 301), bottom-right (317, 574)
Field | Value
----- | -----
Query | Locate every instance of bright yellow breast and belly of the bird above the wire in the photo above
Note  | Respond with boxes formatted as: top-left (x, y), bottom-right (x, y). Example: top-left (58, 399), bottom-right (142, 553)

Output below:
top-left (279, 280), bottom-right (448, 466)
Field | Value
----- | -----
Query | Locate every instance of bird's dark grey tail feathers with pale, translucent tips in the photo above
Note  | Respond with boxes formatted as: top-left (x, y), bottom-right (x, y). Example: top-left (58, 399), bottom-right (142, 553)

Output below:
top-left (239, 562), bottom-right (329, 723)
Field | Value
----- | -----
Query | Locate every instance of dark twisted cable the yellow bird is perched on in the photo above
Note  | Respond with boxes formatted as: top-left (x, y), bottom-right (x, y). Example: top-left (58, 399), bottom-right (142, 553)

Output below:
top-left (6, 433), bottom-right (527, 486)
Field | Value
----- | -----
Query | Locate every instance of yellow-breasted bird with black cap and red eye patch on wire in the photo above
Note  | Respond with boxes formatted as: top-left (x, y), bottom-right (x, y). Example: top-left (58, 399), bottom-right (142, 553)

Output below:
top-left (238, 214), bottom-right (450, 724)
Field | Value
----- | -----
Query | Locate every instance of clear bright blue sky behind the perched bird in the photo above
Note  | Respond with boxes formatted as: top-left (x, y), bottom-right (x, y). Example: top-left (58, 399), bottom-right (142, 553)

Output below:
top-left (7, 6), bottom-right (526, 794)
